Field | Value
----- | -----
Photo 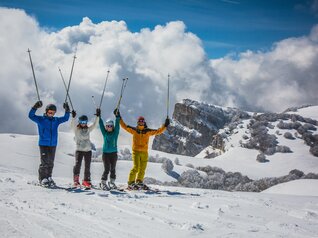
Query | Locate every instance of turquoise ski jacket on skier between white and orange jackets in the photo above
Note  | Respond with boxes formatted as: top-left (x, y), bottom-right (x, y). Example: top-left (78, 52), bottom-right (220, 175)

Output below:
top-left (99, 117), bottom-right (120, 153)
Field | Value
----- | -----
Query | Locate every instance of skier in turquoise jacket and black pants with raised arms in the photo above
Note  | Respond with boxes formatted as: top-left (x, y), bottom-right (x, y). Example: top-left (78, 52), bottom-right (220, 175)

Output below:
top-left (99, 110), bottom-right (120, 190)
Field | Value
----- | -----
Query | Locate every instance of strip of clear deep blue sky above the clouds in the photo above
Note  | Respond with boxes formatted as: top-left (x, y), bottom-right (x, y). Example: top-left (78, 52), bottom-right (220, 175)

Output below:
top-left (0, 0), bottom-right (318, 58)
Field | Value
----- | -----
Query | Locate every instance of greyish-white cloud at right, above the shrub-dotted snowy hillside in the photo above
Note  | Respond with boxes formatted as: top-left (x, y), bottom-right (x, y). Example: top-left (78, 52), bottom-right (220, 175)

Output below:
top-left (206, 26), bottom-right (318, 111)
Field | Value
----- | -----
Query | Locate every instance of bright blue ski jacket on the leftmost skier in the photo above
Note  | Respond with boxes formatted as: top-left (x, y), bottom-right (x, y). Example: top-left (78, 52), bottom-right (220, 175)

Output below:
top-left (29, 108), bottom-right (70, 146)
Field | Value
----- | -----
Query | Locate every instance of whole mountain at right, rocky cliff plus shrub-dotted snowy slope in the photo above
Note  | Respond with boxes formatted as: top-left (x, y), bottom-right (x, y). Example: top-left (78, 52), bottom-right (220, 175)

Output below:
top-left (152, 99), bottom-right (318, 162)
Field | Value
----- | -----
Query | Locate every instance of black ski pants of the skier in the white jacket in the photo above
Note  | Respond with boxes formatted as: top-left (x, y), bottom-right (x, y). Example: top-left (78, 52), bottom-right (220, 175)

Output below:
top-left (73, 150), bottom-right (92, 181)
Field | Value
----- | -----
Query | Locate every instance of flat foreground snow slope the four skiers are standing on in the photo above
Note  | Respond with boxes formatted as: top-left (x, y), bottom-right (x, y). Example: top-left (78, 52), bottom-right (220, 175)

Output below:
top-left (0, 133), bottom-right (318, 238)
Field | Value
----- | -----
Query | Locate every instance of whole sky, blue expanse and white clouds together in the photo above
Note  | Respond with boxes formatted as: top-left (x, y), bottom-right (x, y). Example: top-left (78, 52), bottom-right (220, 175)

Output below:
top-left (0, 0), bottom-right (318, 134)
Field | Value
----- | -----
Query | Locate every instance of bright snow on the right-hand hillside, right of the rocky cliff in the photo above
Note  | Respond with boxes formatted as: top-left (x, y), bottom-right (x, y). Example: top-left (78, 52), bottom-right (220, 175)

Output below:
top-left (194, 106), bottom-right (318, 179)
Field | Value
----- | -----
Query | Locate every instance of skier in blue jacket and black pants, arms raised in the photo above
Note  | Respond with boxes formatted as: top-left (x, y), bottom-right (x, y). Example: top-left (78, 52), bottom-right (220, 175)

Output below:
top-left (29, 101), bottom-right (70, 187)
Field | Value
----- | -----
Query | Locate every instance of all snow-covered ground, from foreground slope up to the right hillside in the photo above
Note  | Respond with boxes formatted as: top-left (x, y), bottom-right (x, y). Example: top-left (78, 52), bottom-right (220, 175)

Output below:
top-left (0, 101), bottom-right (318, 238)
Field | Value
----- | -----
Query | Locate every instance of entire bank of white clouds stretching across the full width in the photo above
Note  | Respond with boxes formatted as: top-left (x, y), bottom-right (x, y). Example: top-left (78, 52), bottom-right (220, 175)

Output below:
top-left (0, 8), bottom-right (318, 136)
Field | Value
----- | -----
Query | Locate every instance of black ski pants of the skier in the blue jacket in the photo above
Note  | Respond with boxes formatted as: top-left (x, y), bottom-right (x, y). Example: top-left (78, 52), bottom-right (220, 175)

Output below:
top-left (39, 146), bottom-right (56, 181)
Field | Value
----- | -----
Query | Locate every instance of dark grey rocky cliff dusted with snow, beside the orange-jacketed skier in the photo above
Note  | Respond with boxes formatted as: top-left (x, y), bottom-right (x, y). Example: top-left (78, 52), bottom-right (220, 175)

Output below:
top-left (152, 99), bottom-right (250, 156)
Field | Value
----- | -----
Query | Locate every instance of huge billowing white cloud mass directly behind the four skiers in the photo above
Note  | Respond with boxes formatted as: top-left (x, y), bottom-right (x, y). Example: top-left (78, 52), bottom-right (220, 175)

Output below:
top-left (0, 8), bottom-right (210, 133)
